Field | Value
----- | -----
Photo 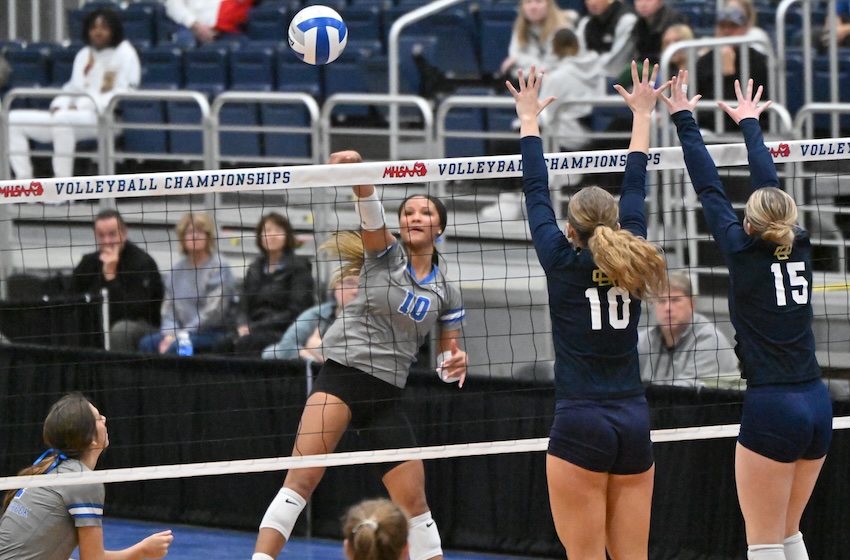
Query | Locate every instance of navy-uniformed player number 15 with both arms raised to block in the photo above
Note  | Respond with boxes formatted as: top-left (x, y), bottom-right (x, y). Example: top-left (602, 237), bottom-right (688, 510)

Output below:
top-left (662, 71), bottom-right (832, 560)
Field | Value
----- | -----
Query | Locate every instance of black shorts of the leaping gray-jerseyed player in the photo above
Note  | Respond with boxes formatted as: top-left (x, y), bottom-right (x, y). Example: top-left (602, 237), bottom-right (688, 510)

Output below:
top-left (313, 360), bottom-right (417, 473)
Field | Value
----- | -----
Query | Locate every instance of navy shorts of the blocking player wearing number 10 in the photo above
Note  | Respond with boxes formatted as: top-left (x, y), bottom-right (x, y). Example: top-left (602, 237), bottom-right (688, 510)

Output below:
top-left (548, 395), bottom-right (653, 474)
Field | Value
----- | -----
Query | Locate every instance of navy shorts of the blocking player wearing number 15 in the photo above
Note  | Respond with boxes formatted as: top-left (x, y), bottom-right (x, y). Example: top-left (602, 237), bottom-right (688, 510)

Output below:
top-left (738, 379), bottom-right (832, 463)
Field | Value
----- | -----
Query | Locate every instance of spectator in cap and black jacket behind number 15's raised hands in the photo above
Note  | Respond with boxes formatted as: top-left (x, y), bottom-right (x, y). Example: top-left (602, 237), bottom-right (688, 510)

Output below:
top-left (696, 4), bottom-right (769, 129)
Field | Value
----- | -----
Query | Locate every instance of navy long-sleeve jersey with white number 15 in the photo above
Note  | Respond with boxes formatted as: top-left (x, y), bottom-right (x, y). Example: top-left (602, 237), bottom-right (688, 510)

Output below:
top-left (673, 111), bottom-right (820, 385)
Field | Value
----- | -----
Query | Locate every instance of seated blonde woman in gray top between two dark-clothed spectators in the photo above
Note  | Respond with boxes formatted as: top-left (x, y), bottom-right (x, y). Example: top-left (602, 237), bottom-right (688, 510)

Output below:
top-left (139, 212), bottom-right (235, 354)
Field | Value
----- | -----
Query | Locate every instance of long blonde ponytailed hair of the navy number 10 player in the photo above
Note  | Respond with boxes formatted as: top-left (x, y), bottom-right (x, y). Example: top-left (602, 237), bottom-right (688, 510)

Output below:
top-left (569, 187), bottom-right (667, 298)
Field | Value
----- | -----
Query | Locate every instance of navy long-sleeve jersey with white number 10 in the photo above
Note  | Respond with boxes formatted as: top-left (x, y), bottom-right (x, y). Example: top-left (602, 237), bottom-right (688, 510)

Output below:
top-left (521, 136), bottom-right (648, 399)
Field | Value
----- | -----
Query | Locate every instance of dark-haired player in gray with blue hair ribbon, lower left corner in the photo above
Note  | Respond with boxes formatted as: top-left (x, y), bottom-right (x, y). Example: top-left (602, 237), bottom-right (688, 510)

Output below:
top-left (0, 393), bottom-right (174, 560)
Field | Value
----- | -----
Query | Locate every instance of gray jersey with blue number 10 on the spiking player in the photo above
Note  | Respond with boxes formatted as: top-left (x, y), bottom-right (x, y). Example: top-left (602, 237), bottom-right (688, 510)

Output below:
top-left (322, 241), bottom-right (465, 388)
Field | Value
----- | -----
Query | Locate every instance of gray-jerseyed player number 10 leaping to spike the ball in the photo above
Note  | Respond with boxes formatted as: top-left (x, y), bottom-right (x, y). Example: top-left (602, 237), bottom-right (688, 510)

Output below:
top-left (252, 151), bottom-right (466, 560)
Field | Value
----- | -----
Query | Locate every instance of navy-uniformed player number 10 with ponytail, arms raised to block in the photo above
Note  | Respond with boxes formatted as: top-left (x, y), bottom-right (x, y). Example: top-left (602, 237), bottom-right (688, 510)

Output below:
top-left (507, 61), bottom-right (669, 560)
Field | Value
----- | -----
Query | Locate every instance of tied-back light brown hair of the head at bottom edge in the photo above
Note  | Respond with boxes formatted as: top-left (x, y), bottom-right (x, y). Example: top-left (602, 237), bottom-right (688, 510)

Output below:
top-left (342, 499), bottom-right (409, 560)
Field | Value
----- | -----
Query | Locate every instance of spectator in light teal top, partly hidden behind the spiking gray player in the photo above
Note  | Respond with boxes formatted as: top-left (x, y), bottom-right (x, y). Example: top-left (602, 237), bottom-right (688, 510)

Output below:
top-left (263, 232), bottom-right (363, 363)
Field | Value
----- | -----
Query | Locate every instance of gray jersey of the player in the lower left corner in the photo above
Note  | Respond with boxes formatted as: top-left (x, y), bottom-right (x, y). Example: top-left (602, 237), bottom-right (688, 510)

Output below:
top-left (0, 459), bottom-right (105, 560)
